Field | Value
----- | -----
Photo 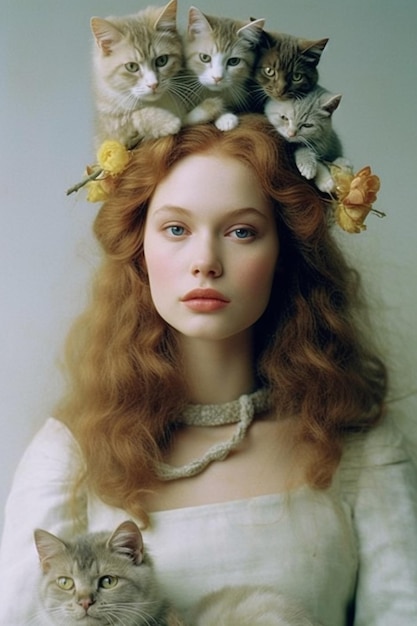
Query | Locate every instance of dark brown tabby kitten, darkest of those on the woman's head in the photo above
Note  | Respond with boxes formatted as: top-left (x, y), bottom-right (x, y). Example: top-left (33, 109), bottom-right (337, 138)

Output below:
top-left (255, 32), bottom-right (328, 99)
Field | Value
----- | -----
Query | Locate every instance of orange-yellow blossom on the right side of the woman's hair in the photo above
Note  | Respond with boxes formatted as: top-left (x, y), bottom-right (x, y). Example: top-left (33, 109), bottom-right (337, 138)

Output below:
top-left (330, 166), bottom-right (380, 233)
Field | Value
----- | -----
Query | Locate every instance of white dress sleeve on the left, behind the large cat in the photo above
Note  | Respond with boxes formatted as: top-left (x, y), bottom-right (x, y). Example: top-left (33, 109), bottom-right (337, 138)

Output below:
top-left (0, 419), bottom-right (86, 626)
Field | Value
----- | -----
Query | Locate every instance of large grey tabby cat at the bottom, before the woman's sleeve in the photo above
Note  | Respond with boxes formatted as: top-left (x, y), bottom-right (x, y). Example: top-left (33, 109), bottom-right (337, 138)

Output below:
top-left (34, 521), bottom-right (185, 626)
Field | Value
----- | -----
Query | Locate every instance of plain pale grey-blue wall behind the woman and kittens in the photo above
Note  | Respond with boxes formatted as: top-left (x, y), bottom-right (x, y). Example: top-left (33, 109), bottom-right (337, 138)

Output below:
top-left (0, 0), bottom-right (417, 532)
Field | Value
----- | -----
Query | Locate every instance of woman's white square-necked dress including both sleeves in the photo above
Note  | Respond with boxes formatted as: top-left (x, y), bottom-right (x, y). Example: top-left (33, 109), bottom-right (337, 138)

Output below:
top-left (0, 418), bottom-right (417, 626)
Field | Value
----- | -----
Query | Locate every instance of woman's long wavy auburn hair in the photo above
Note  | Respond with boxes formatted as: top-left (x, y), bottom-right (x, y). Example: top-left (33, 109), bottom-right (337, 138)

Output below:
top-left (57, 114), bottom-right (387, 517)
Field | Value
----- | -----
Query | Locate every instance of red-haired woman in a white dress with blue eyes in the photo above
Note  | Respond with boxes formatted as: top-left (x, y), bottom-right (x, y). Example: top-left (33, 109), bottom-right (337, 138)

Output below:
top-left (0, 115), bottom-right (417, 626)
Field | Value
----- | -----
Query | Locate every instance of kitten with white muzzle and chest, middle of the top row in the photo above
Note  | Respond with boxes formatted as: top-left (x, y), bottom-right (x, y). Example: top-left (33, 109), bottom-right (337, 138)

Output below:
top-left (184, 7), bottom-right (264, 130)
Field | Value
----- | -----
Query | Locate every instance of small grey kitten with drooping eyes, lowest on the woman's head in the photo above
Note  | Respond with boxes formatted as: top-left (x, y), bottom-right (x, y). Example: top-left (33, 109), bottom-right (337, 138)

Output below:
top-left (264, 85), bottom-right (349, 193)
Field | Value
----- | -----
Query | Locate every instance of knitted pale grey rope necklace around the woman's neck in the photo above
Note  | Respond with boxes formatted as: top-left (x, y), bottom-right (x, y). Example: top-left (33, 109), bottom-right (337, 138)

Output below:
top-left (157, 389), bottom-right (270, 481)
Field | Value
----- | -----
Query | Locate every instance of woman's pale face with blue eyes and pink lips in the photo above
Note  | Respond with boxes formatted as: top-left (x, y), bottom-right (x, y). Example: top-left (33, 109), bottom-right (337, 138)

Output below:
top-left (144, 153), bottom-right (279, 340)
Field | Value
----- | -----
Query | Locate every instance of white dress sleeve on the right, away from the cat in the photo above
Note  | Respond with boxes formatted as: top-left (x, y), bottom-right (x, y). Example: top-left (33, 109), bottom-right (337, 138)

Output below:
top-left (342, 414), bottom-right (417, 626)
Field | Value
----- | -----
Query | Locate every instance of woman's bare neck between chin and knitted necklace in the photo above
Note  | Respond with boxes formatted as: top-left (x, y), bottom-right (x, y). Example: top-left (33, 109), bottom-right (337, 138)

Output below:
top-left (180, 335), bottom-right (255, 404)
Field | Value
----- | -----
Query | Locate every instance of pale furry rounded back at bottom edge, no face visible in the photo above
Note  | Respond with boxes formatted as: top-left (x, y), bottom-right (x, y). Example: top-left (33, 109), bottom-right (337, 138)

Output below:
top-left (190, 585), bottom-right (319, 626)
